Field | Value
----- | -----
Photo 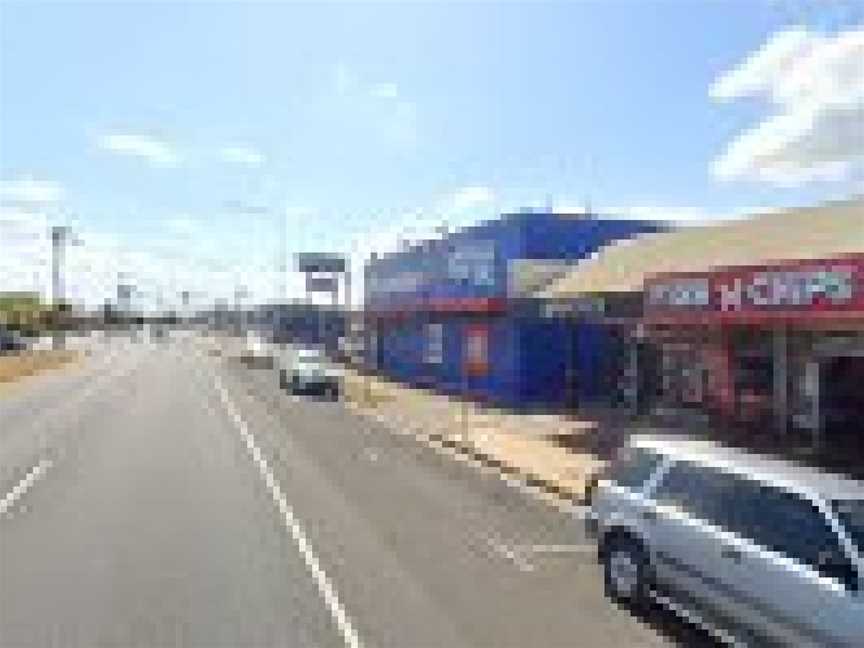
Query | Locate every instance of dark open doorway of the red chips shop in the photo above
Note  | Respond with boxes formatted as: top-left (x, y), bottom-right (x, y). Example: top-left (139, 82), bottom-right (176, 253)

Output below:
top-left (819, 356), bottom-right (864, 459)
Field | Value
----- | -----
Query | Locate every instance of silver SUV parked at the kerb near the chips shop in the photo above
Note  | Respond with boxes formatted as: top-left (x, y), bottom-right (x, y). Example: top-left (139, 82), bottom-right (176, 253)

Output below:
top-left (589, 435), bottom-right (864, 647)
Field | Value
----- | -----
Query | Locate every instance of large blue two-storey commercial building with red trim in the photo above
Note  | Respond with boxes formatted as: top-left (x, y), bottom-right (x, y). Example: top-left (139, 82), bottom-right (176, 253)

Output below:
top-left (365, 212), bottom-right (659, 407)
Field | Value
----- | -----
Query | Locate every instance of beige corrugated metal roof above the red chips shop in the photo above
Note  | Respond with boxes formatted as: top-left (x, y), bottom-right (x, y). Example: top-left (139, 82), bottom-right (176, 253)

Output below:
top-left (538, 198), bottom-right (864, 299)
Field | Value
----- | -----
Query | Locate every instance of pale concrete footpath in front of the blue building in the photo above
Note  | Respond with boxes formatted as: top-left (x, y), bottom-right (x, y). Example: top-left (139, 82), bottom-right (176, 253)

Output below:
top-left (344, 369), bottom-right (627, 503)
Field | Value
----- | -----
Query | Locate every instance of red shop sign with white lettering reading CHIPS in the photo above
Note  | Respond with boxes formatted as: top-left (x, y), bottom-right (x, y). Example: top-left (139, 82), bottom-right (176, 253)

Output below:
top-left (645, 255), bottom-right (864, 319)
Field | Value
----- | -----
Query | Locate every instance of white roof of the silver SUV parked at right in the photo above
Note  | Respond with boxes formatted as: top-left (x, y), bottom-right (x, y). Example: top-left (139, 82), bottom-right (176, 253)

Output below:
top-left (629, 433), bottom-right (864, 500)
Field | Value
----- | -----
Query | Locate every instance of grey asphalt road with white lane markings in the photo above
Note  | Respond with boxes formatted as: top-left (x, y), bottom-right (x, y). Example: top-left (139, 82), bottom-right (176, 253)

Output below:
top-left (0, 336), bottom-right (716, 648)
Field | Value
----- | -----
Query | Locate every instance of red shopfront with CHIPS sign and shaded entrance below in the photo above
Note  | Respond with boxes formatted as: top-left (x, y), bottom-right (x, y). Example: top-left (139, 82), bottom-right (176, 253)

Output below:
top-left (645, 254), bottom-right (864, 450)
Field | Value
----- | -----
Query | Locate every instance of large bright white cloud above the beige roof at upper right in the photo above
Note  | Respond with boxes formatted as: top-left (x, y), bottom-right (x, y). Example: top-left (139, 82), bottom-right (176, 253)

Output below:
top-left (709, 27), bottom-right (864, 185)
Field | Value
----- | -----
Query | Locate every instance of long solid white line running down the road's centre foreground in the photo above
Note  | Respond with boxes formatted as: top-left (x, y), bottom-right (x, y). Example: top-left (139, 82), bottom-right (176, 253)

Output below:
top-left (213, 375), bottom-right (363, 648)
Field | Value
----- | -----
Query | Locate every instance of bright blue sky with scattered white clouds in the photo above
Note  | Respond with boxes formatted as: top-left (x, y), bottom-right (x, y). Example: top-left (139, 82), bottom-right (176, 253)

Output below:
top-left (0, 0), bottom-right (864, 308)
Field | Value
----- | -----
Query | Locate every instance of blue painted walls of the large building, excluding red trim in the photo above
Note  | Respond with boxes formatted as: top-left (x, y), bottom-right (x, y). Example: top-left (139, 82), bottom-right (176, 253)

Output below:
top-left (366, 213), bottom-right (660, 406)
